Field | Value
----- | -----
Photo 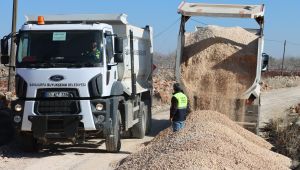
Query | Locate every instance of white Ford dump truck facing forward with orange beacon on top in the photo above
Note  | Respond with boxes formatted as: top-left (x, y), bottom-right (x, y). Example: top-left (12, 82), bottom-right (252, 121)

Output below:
top-left (1, 14), bottom-right (153, 152)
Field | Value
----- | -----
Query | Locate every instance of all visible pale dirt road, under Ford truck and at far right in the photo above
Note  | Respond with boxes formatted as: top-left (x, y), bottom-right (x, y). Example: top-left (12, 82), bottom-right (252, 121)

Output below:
top-left (0, 87), bottom-right (300, 170)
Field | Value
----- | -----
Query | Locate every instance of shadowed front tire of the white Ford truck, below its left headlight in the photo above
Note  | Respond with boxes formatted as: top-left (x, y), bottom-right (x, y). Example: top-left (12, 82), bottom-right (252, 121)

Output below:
top-left (17, 132), bottom-right (40, 152)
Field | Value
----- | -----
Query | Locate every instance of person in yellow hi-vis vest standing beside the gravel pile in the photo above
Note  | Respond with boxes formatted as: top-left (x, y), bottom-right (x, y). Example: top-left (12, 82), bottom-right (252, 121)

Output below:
top-left (170, 83), bottom-right (188, 132)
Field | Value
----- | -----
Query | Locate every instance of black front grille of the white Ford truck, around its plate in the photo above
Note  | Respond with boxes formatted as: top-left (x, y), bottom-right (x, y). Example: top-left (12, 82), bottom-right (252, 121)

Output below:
top-left (34, 89), bottom-right (80, 115)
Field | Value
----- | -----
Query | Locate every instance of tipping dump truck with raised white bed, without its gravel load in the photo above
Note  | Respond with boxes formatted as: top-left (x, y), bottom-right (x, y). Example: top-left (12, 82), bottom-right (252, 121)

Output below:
top-left (175, 1), bottom-right (268, 133)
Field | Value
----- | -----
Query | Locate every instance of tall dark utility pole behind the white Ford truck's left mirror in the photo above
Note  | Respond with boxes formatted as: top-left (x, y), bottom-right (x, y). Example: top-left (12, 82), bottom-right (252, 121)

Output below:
top-left (8, 0), bottom-right (18, 91)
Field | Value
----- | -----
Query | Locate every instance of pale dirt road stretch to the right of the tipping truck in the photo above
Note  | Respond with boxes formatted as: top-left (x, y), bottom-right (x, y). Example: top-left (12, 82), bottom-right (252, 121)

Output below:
top-left (260, 86), bottom-right (300, 126)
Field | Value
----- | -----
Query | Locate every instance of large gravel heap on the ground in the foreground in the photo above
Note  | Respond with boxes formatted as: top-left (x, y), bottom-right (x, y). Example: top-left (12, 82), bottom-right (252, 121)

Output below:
top-left (117, 111), bottom-right (290, 170)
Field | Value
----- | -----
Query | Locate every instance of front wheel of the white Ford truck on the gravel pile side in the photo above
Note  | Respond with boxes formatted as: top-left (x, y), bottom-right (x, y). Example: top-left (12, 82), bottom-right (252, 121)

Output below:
top-left (105, 110), bottom-right (122, 153)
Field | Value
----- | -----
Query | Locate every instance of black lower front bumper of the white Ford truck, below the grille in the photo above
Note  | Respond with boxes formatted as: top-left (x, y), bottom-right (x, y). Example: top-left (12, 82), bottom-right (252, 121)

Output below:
top-left (28, 115), bottom-right (82, 140)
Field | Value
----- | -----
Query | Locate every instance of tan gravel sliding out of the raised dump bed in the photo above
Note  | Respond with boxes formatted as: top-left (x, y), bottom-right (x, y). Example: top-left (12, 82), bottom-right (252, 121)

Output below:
top-left (181, 26), bottom-right (258, 122)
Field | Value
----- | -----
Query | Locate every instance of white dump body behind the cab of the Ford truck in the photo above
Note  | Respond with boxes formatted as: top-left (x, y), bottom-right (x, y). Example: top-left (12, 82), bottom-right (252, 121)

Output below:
top-left (111, 23), bottom-right (153, 95)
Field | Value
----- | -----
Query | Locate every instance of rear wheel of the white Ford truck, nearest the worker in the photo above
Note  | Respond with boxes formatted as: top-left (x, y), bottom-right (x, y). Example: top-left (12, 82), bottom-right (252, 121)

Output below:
top-left (132, 102), bottom-right (147, 139)
